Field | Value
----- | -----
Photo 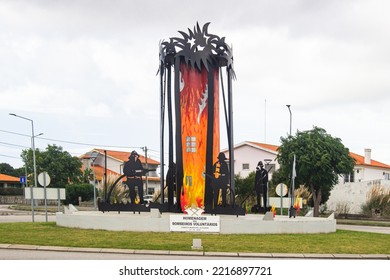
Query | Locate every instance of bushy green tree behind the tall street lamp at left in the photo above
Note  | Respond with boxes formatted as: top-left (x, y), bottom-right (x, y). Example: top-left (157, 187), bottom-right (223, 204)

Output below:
top-left (21, 145), bottom-right (82, 188)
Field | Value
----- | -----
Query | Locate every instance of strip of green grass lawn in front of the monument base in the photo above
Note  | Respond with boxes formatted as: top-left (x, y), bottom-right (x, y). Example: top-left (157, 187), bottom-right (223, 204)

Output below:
top-left (0, 222), bottom-right (390, 254)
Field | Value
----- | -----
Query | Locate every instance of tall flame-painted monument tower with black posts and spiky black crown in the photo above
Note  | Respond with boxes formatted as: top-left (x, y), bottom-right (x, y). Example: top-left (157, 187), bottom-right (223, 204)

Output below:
top-left (159, 23), bottom-right (245, 215)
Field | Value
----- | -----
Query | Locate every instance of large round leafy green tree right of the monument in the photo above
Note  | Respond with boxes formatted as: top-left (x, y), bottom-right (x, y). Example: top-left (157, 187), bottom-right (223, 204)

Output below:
top-left (277, 127), bottom-right (355, 217)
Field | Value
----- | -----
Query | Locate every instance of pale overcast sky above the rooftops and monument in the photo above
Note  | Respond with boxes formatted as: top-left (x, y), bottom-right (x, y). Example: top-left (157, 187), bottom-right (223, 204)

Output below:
top-left (0, 0), bottom-right (390, 168)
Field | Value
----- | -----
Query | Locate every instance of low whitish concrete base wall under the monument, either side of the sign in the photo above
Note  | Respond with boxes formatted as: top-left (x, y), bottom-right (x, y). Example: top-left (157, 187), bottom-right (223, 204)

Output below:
top-left (56, 211), bottom-right (336, 234)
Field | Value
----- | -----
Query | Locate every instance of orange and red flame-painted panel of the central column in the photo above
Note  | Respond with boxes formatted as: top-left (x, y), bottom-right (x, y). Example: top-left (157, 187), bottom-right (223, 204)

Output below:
top-left (180, 64), bottom-right (220, 211)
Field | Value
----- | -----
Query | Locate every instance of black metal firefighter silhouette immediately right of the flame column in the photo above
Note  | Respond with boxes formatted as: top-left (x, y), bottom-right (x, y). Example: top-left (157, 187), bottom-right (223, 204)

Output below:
top-left (211, 153), bottom-right (229, 209)
